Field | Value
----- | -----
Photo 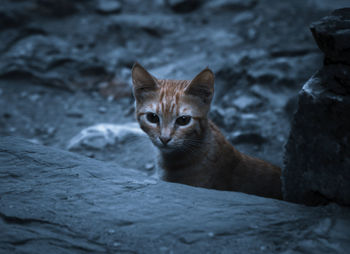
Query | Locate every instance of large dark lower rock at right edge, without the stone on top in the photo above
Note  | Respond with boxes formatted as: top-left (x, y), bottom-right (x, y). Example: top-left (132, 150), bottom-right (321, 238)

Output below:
top-left (283, 69), bottom-right (350, 205)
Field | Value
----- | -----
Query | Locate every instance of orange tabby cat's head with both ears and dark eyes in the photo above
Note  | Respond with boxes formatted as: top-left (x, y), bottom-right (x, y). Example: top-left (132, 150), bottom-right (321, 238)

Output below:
top-left (132, 63), bottom-right (214, 152)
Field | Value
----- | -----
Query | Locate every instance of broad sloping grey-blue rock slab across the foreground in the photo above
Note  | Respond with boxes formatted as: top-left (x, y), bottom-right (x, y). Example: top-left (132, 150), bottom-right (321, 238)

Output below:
top-left (0, 137), bottom-right (350, 253)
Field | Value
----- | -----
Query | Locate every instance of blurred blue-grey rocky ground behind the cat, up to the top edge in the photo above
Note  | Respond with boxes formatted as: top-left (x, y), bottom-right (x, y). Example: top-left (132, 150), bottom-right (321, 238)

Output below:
top-left (0, 0), bottom-right (349, 174)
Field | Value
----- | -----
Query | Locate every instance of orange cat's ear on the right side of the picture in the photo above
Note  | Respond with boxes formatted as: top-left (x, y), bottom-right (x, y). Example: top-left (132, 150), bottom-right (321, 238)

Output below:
top-left (185, 67), bottom-right (215, 103)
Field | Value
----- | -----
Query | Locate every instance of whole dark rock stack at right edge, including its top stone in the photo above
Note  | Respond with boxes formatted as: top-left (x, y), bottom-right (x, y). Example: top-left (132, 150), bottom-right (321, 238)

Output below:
top-left (283, 8), bottom-right (350, 205)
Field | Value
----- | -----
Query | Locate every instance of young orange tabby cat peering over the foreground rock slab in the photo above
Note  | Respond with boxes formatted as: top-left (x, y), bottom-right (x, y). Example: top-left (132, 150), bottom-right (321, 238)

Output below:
top-left (132, 63), bottom-right (282, 199)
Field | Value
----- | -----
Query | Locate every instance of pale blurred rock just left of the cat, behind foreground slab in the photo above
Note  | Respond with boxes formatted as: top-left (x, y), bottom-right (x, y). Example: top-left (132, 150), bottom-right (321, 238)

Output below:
top-left (67, 122), bottom-right (158, 174)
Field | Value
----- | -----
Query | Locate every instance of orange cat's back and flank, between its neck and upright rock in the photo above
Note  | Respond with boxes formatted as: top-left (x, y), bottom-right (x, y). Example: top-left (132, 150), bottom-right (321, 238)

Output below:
top-left (209, 122), bottom-right (282, 199)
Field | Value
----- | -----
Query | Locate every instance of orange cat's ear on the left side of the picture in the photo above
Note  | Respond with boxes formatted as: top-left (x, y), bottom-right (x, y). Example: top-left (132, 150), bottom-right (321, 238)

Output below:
top-left (131, 63), bottom-right (158, 101)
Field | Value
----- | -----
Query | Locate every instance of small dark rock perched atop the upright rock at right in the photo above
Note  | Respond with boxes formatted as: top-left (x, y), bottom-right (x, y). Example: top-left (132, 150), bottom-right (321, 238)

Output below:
top-left (311, 8), bottom-right (350, 65)
